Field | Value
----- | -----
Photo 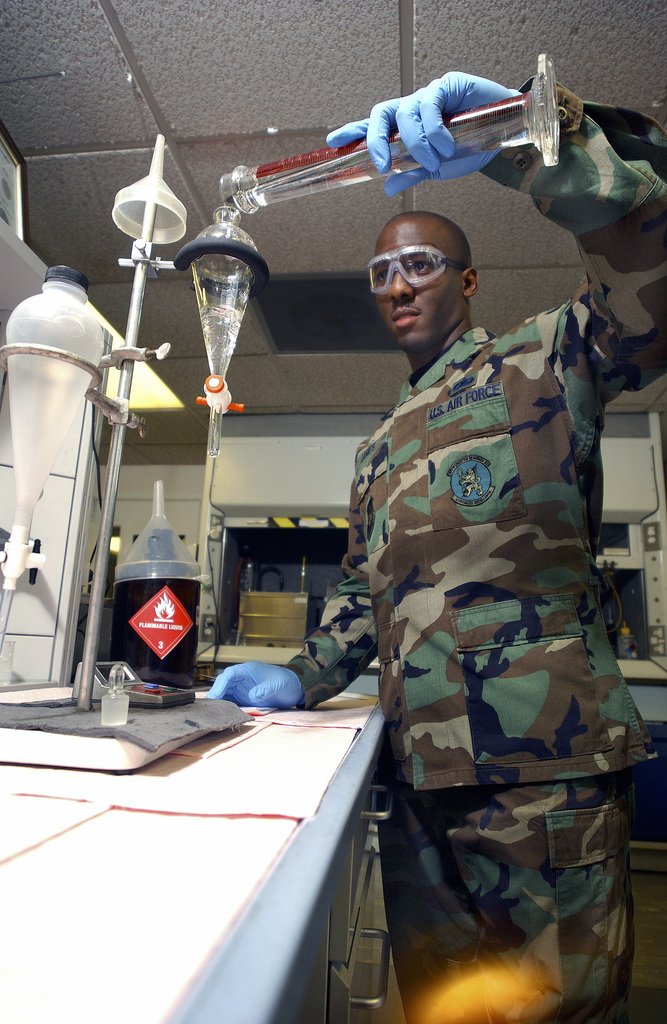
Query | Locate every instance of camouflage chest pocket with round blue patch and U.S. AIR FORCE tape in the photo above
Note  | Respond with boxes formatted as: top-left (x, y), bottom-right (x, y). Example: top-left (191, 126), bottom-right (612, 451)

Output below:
top-left (426, 384), bottom-right (526, 529)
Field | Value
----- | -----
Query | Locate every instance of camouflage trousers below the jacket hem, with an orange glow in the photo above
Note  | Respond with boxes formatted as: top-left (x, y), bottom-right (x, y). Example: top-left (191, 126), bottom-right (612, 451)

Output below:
top-left (380, 769), bottom-right (634, 1024)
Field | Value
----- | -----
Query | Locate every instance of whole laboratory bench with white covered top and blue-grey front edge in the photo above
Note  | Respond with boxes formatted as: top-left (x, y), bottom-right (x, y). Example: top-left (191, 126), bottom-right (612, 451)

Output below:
top-left (0, 691), bottom-right (389, 1024)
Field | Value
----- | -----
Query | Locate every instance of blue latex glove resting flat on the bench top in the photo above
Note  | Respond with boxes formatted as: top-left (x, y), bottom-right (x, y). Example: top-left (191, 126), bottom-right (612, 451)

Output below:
top-left (206, 662), bottom-right (305, 708)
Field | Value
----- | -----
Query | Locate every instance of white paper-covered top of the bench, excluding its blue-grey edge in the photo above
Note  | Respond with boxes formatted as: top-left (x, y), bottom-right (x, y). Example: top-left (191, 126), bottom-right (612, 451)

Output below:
top-left (0, 700), bottom-right (381, 1024)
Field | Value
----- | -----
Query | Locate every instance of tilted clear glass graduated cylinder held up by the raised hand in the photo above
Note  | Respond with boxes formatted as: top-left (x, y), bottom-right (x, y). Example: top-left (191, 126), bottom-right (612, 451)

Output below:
top-left (220, 53), bottom-right (558, 213)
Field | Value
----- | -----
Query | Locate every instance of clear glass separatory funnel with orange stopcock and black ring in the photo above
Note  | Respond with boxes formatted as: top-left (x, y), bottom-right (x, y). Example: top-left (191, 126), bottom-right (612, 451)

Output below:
top-left (174, 206), bottom-right (268, 459)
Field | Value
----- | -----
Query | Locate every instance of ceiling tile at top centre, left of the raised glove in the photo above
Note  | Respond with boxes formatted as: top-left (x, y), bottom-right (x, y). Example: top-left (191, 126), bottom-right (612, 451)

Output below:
top-left (114, 0), bottom-right (400, 136)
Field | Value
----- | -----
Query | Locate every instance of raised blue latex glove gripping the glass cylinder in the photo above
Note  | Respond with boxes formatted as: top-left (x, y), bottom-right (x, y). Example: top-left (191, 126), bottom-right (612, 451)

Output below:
top-left (327, 72), bottom-right (518, 196)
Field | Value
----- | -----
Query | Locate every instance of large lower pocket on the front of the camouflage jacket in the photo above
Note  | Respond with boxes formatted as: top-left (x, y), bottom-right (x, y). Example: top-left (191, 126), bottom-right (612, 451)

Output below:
top-left (453, 594), bottom-right (611, 764)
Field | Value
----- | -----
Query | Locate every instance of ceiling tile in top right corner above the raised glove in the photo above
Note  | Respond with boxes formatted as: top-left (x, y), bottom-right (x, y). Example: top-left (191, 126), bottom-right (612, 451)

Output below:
top-left (415, 0), bottom-right (667, 114)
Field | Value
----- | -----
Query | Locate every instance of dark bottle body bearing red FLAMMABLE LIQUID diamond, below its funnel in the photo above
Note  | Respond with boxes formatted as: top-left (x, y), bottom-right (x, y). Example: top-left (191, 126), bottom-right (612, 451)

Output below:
top-left (110, 577), bottom-right (201, 690)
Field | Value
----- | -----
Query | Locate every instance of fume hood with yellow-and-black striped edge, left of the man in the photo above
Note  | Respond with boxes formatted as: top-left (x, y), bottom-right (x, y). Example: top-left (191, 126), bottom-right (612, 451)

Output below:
top-left (199, 436), bottom-right (362, 652)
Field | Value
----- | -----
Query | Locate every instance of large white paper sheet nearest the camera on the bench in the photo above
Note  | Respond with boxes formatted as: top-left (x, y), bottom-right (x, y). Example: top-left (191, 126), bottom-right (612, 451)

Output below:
top-left (0, 806), bottom-right (298, 1024)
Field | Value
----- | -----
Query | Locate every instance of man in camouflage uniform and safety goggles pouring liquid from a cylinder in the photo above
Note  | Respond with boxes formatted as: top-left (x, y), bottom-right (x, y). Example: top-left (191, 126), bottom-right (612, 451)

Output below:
top-left (211, 68), bottom-right (667, 1024)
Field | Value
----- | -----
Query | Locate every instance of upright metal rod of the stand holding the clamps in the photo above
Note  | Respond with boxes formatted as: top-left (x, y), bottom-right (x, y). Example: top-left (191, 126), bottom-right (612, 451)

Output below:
top-left (77, 225), bottom-right (157, 711)
